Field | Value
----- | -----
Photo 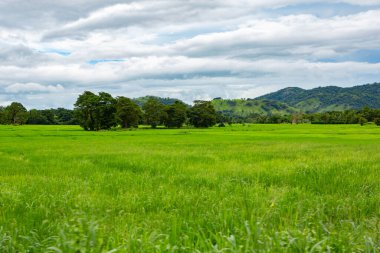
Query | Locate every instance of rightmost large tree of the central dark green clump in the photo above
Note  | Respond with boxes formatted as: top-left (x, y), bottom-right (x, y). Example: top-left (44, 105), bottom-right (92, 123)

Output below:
top-left (189, 100), bottom-right (216, 127)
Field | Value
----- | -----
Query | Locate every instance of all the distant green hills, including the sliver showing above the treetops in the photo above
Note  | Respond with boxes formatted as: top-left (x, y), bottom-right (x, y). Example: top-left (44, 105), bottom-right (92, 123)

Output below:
top-left (134, 83), bottom-right (380, 117)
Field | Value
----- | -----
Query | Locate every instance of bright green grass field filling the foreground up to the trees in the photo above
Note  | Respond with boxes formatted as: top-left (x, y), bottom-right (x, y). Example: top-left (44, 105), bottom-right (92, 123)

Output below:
top-left (0, 125), bottom-right (380, 253)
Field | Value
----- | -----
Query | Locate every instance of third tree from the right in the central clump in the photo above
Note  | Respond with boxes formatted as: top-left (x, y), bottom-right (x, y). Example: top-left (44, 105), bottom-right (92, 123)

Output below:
top-left (143, 97), bottom-right (167, 128)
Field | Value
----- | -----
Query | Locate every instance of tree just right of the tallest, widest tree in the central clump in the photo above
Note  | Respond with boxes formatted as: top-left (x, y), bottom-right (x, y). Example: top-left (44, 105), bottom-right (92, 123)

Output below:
top-left (116, 97), bottom-right (141, 128)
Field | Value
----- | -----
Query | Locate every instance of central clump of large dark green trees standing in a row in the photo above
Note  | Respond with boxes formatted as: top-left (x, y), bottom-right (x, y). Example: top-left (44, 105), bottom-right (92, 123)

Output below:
top-left (74, 91), bottom-right (217, 131)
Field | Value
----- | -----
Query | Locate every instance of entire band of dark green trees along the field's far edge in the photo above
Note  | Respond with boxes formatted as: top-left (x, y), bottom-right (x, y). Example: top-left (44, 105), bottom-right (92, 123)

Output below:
top-left (0, 91), bottom-right (380, 128)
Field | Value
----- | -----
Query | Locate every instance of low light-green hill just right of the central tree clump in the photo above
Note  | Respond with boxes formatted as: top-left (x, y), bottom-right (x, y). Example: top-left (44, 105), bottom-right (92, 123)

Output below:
top-left (212, 98), bottom-right (299, 117)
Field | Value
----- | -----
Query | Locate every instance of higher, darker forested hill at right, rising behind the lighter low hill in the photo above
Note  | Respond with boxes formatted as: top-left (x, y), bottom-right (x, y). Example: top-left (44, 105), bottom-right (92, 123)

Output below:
top-left (256, 83), bottom-right (380, 113)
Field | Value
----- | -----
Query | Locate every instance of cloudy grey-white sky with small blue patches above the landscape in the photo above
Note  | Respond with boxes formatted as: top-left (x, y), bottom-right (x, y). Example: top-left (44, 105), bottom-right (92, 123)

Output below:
top-left (0, 0), bottom-right (380, 108)
